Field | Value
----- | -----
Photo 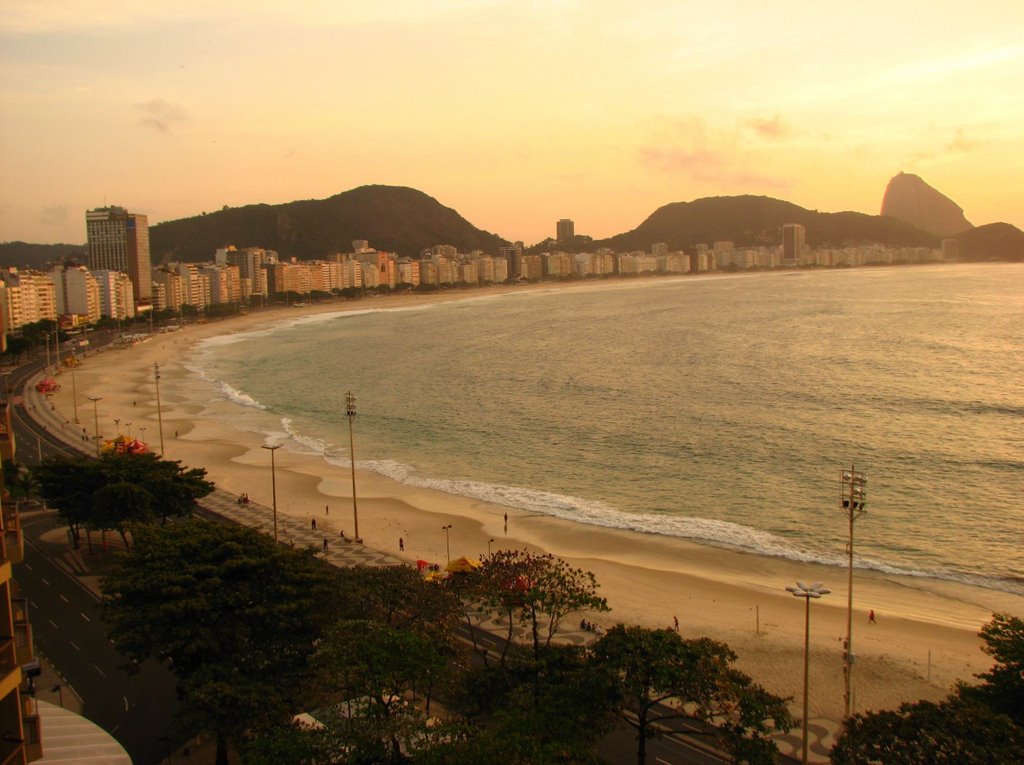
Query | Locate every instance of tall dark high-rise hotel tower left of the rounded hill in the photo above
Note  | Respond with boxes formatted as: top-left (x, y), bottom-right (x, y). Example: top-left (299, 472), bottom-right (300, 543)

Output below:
top-left (85, 207), bottom-right (153, 305)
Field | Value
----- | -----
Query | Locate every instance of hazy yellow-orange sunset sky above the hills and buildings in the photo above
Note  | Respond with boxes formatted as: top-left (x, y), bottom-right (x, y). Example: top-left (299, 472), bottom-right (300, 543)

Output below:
top-left (0, 0), bottom-right (1024, 245)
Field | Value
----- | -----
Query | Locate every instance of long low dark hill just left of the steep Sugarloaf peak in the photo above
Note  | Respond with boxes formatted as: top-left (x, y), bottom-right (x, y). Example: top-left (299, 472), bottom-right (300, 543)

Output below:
top-left (594, 196), bottom-right (938, 251)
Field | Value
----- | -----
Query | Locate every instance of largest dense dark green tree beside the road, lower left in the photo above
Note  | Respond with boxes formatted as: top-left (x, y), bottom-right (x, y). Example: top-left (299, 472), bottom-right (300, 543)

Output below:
top-left (102, 520), bottom-right (346, 765)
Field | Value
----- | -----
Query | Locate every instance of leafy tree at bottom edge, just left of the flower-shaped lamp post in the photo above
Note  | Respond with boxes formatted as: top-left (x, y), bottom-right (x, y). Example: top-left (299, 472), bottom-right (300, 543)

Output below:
top-left (592, 625), bottom-right (793, 765)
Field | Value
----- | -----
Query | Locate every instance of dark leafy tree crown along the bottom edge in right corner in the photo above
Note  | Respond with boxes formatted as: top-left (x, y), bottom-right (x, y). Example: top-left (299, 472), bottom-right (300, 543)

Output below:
top-left (831, 696), bottom-right (1024, 765)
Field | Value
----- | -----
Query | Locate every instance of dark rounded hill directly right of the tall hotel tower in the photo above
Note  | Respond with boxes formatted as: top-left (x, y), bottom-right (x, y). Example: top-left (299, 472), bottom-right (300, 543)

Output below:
top-left (150, 185), bottom-right (507, 263)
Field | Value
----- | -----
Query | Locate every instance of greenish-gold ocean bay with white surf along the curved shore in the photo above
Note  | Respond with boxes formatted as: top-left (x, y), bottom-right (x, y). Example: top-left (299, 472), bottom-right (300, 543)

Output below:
top-left (189, 264), bottom-right (1024, 594)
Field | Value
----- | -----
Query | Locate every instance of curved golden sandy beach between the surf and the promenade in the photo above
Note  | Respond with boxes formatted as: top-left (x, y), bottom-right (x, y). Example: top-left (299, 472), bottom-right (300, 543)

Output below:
top-left (32, 285), bottom-right (1024, 741)
